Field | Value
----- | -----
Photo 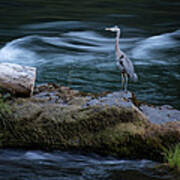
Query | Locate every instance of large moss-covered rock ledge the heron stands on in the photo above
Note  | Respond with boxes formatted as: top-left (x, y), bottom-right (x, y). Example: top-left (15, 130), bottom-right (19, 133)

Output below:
top-left (0, 84), bottom-right (180, 160)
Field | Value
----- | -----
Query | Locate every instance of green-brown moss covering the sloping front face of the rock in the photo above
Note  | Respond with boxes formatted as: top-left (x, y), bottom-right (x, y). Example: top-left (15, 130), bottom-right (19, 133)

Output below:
top-left (0, 97), bottom-right (179, 160)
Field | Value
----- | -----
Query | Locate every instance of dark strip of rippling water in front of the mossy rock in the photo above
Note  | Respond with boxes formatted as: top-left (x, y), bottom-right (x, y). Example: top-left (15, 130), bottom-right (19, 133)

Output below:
top-left (0, 150), bottom-right (173, 180)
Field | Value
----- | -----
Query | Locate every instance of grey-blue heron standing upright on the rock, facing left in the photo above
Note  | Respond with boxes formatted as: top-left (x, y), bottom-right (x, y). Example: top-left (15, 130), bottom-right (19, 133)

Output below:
top-left (105, 26), bottom-right (138, 91)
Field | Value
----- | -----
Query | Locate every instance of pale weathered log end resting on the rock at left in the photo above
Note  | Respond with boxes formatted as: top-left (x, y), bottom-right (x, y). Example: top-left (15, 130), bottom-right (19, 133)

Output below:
top-left (0, 63), bottom-right (36, 96)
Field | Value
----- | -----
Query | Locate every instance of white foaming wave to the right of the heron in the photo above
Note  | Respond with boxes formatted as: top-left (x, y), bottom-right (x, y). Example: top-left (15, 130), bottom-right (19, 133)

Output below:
top-left (131, 30), bottom-right (180, 65)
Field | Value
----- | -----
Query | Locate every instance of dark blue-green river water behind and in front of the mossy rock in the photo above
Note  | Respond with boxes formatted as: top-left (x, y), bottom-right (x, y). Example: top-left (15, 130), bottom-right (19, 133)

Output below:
top-left (0, 0), bottom-right (180, 180)
